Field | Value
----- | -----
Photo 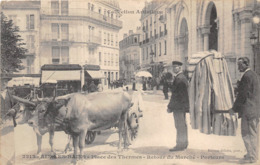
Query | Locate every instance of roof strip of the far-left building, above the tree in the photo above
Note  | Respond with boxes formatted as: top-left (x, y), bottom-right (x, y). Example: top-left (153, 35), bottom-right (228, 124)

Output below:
top-left (1, 1), bottom-right (41, 9)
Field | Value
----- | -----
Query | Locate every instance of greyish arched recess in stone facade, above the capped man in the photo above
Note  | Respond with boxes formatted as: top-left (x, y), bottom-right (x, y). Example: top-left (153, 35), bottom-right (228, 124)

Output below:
top-left (179, 18), bottom-right (189, 70)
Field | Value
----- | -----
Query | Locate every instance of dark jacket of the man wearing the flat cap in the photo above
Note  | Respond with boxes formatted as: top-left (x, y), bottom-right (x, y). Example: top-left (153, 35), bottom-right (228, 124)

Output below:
top-left (168, 73), bottom-right (189, 112)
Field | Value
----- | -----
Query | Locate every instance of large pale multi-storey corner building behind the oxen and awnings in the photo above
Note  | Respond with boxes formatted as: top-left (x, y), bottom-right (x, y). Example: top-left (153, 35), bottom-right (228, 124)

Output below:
top-left (3, 0), bottom-right (122, 87)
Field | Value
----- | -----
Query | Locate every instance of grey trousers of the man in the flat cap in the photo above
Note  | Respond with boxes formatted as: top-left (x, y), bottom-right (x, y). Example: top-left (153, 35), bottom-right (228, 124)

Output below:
top-left (173, 111), bottom-right (188, 148)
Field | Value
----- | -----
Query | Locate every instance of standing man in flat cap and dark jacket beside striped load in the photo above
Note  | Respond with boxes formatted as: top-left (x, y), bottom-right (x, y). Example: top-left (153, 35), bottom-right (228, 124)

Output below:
top-left (167, 61), bottom-right (189, 152)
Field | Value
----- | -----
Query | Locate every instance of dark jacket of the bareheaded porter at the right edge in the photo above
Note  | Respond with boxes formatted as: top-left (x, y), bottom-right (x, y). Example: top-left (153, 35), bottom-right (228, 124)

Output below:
top-left (233, 70), bottom-right (260, 118)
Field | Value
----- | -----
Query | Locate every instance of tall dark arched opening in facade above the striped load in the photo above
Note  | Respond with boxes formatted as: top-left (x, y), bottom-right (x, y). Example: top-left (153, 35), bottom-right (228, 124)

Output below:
top-left (206, 2), bottom-right (218, 51)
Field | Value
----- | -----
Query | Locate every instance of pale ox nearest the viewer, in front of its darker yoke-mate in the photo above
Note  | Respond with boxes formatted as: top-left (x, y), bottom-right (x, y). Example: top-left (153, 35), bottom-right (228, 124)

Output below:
top-left (28, 91), bottom-right (133, 160)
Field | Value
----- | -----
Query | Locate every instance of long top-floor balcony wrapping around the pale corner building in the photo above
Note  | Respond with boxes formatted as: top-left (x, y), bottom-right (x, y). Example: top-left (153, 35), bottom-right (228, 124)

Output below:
top-left (41, 8), bottom-right (122, 29)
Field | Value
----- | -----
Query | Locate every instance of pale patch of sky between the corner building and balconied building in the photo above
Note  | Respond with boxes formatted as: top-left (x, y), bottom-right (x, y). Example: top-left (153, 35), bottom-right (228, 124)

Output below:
top-left (118, 0), bottom-right (145, 41)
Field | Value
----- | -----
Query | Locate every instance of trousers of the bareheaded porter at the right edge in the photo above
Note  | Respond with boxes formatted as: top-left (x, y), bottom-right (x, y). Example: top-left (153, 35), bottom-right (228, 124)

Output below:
top-left (241, 115), bottom-right (259, 160)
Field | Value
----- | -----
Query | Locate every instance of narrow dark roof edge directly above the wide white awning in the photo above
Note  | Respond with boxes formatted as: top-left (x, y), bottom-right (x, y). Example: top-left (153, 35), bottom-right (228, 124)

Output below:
top-left (41, 64), bottom-right (82, 70)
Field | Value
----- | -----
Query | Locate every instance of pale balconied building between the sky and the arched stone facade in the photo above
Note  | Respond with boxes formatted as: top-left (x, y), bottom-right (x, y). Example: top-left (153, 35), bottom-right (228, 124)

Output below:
top-left (140, 0), bottom-right (171, 77)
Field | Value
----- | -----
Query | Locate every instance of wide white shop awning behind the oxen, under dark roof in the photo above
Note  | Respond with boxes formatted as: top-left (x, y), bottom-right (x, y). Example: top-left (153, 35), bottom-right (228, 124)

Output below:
top-left (41, 70), bottom-right (81, 83)
